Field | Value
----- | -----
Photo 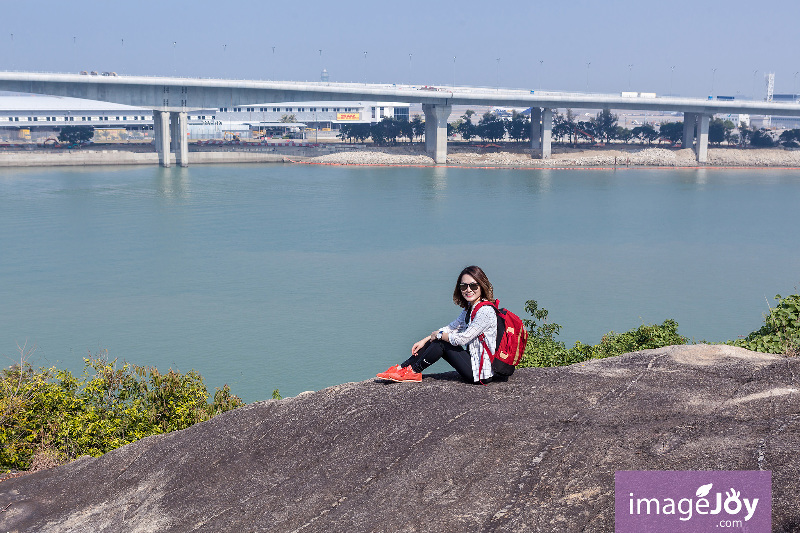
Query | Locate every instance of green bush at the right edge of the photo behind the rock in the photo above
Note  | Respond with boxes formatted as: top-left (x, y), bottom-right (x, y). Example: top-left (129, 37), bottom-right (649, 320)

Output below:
top-left (729, 294), bottom-right (800, 356)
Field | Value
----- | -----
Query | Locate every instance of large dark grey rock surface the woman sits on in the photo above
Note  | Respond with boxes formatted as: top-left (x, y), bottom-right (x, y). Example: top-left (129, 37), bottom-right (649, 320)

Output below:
top-left (0, 345), bottom-right (800, 533)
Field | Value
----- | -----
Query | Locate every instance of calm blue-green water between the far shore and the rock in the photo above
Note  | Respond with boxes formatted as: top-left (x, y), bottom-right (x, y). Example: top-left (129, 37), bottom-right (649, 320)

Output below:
top-left (0, 165), bottom-right (800, 402)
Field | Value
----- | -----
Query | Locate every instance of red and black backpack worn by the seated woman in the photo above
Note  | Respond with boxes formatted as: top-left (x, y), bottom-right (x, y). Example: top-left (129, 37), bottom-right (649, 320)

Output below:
top-left (470, 300), bottom-right (528, 376)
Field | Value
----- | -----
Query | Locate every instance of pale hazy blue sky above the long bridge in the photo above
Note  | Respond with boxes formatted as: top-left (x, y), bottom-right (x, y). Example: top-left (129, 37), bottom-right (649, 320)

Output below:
top-left (0, 0), bottom-right (800, 98)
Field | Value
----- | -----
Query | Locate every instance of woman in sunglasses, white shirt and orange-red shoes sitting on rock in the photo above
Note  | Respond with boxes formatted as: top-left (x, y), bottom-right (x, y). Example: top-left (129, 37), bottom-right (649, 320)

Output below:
top-left (378, 266), bottom-right (497, 383)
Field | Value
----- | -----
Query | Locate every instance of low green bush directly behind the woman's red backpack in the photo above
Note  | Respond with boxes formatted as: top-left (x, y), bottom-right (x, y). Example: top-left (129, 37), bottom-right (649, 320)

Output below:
top-left (520, 300), bottom-right (688, 366)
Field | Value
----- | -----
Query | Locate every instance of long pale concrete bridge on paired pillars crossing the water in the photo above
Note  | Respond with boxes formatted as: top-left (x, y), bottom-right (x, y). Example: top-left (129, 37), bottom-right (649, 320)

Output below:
top-left (0, 72), bottom-right (800, 166)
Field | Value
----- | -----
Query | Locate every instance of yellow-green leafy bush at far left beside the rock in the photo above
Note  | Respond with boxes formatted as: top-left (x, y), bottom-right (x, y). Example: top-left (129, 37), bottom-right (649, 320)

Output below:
top-left (0, 352), bottom-right (243, 471)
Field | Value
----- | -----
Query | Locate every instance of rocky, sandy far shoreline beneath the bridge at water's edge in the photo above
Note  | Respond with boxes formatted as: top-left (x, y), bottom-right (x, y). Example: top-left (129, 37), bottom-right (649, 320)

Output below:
top-left (0, 143), bottom-right (800, 170)
